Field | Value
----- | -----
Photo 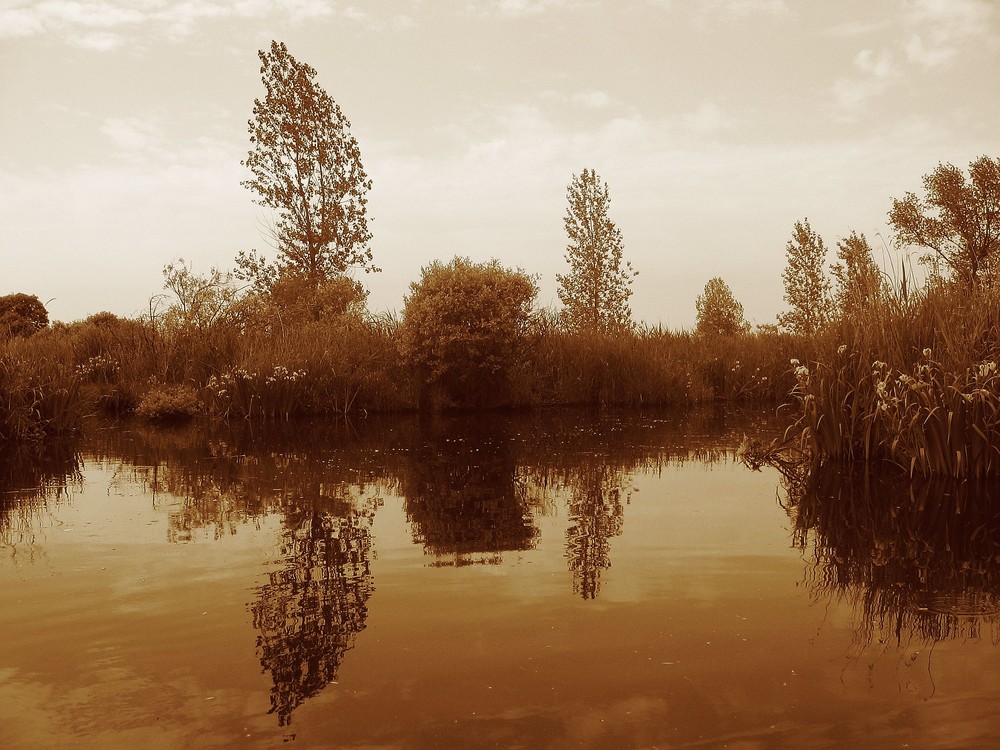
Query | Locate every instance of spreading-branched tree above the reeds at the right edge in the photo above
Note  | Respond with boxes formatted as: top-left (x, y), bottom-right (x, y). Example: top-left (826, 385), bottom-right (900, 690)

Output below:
top-left (889, 156), bottom-right (1000, 288)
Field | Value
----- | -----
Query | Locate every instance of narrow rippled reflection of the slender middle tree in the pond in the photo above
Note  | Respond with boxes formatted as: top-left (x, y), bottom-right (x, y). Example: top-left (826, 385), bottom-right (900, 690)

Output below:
top-left (566, 463), bottom-right (627, 599)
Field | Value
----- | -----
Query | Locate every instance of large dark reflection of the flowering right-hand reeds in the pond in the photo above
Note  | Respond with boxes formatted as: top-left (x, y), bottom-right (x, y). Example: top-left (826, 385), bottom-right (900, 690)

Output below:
top-left (788, 471), bottom-right (1000, 643)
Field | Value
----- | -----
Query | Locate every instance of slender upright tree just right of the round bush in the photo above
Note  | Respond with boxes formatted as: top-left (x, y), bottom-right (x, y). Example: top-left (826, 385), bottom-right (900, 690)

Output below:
top-left (556, 169), bottom-right (638, 333)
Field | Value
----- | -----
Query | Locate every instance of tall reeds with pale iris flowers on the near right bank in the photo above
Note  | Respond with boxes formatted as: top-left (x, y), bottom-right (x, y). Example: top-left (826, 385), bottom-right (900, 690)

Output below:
top-left (785, 285), bottom-right (1000, 479)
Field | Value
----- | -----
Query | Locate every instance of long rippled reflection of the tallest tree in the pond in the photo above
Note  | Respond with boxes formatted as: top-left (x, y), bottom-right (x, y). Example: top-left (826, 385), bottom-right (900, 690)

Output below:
top-left (251, 501), bottom-right (377, 725)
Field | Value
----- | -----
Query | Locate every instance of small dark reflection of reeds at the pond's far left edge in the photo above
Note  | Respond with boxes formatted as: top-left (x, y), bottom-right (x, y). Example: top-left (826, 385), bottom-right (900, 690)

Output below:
top-left (0, 442), bottom-right (83, 555)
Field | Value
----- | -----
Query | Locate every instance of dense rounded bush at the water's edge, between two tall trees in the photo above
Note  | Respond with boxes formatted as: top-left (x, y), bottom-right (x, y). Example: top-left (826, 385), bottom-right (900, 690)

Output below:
top-left (402, 258), bottom-right (538, 412)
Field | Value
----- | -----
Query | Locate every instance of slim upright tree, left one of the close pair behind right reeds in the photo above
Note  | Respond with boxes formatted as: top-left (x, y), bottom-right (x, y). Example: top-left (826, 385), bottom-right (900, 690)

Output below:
top-left (778, 219), bottom-right (833, 336)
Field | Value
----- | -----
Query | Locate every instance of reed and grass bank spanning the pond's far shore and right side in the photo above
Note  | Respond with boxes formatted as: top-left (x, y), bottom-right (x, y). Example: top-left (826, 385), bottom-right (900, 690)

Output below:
top-left (0, 276), bottom-right (1000, 479)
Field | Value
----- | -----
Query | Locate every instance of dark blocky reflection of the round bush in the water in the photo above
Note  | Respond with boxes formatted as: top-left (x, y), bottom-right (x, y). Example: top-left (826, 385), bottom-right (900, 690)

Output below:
top-left (400, 420), bottom-right (538, 565)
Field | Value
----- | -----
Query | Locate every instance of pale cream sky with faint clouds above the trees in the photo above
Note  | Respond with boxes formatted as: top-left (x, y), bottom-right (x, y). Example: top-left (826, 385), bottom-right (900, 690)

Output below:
top-left (0, 0), bottom-right (1000, 329)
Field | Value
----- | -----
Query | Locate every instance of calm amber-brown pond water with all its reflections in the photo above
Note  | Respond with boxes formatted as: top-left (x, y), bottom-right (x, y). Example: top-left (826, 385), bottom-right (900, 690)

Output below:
top-left (0, 410), bottom-right (1000, 749)
